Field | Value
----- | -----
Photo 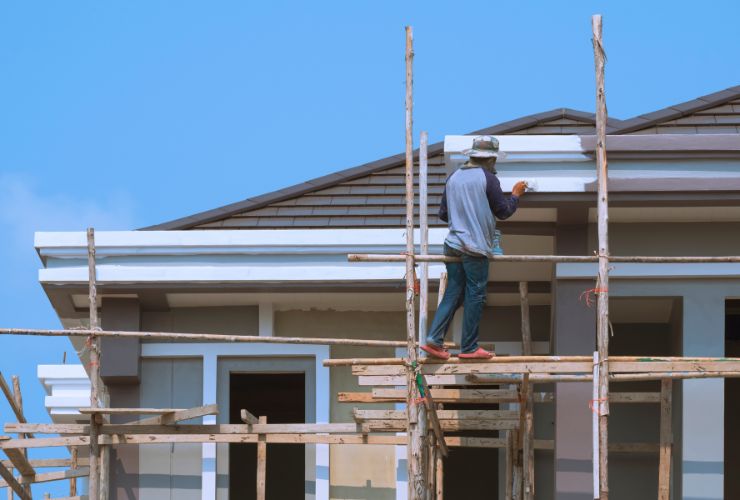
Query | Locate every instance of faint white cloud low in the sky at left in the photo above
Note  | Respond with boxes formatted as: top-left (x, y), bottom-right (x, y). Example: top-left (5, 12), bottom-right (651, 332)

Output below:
top-left (0, 173), bottom-right (134, 251)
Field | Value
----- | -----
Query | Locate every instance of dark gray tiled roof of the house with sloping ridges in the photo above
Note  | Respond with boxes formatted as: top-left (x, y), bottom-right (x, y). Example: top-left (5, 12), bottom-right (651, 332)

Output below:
top-left (143, 86), bottom-right (740, 230)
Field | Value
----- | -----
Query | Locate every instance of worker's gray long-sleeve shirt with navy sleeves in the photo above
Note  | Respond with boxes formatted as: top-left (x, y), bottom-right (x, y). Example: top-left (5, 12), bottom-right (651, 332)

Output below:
top-left (439, 164), bottom-right (519, 256)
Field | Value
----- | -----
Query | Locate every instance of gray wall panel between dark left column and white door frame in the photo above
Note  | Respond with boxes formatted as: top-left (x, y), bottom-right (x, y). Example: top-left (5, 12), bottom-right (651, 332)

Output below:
top-left (139, 358), bottom-right (203, 500)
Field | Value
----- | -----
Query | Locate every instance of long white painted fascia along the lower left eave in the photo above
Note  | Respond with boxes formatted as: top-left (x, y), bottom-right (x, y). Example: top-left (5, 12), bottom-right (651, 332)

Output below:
top-left (36, 228), bottom-right (447, 284)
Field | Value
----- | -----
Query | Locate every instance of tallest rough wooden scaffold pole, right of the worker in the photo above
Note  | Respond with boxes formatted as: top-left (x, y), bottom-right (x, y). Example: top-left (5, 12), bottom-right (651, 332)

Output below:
top-left (591, 14), bottom-right (609, 500)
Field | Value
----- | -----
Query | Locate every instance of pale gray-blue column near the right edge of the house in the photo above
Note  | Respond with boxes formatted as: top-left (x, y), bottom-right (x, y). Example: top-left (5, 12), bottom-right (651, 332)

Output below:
top-left (680, 288), bottom-right (725, 500)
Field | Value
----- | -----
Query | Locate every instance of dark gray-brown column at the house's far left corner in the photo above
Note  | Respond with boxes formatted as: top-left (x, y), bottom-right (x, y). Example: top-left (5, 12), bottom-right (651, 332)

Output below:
top-left (100, 297), bottom-right (141, 500)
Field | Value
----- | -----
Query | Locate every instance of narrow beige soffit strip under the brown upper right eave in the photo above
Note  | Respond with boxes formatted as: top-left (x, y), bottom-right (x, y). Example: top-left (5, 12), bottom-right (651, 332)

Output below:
top-left (588, 207), bottom-right (740, 223)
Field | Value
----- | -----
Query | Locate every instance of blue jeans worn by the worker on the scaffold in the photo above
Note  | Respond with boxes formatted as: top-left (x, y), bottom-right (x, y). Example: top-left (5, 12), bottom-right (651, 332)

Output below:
top-left (427, 244), bottom-right (488, 353)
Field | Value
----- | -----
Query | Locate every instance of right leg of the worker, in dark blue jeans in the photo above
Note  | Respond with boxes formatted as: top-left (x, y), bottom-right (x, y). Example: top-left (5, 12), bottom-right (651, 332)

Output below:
top-left (461, 255), bottom-right (488, 353)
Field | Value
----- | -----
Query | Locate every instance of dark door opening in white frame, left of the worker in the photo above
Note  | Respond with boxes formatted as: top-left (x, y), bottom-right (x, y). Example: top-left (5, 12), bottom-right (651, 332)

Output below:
top-left (229, 373), bottom-right (306, 500)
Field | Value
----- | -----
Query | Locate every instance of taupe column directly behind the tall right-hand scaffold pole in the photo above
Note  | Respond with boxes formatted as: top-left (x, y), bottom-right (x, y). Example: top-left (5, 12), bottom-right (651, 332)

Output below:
top-left (553, 280), bottom-right (596, 500)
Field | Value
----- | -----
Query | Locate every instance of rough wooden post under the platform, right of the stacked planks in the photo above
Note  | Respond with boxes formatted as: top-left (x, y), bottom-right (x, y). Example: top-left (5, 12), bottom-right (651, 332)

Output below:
top-left (519, 281), bottom-right (534, 500)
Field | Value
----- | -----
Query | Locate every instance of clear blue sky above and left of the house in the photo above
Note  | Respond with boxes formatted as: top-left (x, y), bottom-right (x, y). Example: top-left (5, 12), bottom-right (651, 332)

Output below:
top-left (0, 0), bottom-right (740, 492)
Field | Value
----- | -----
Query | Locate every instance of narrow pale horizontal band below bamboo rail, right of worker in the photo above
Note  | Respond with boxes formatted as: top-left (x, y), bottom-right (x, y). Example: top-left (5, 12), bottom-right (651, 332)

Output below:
top-left (555, 262), bottom-right (740, 279)
